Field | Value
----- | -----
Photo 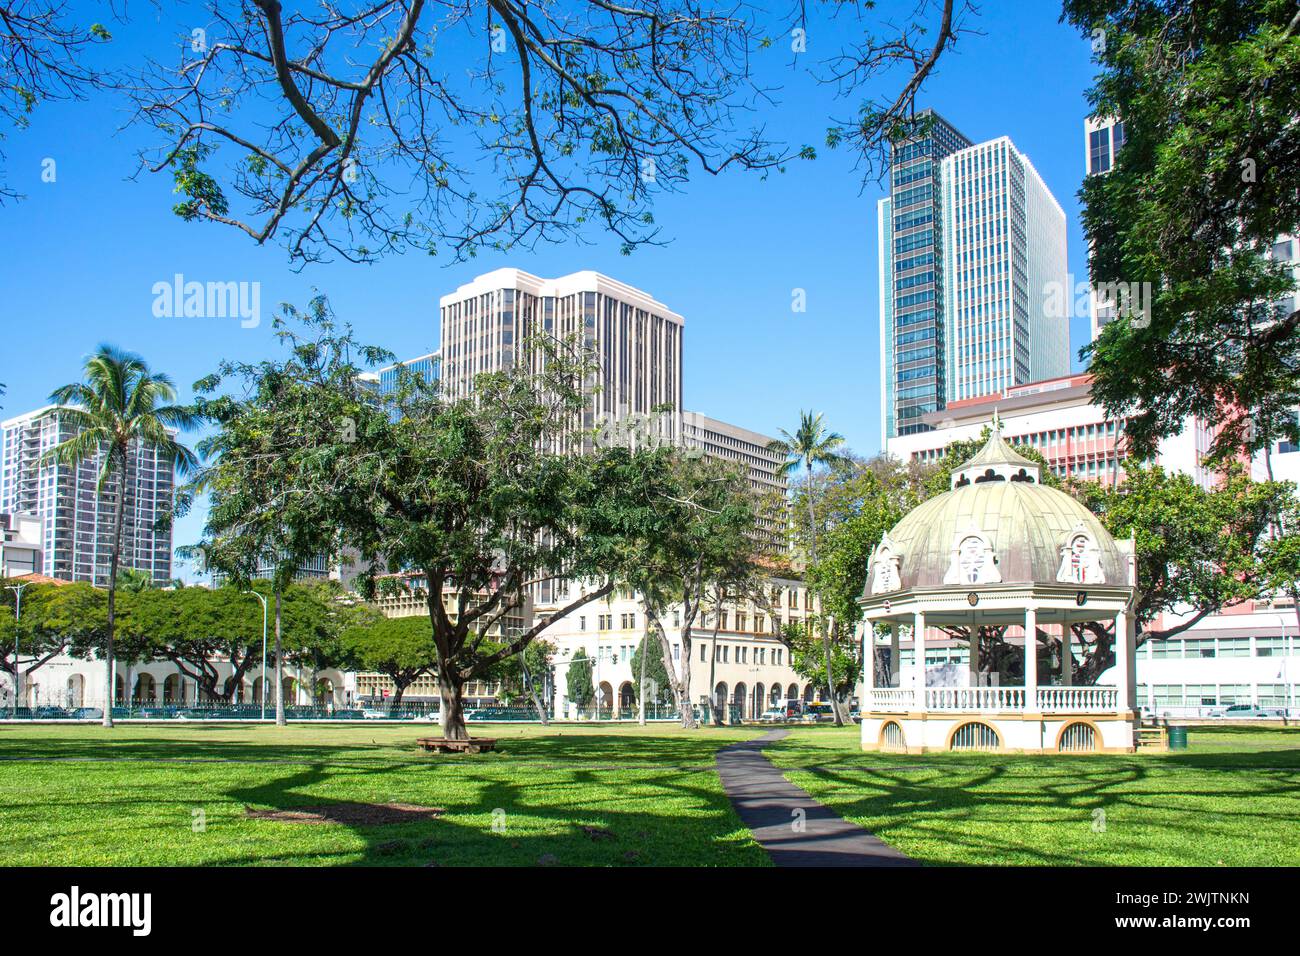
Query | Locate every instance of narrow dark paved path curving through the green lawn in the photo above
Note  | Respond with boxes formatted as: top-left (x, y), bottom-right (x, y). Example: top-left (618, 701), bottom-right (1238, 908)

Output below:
top-left (718, 730), bottom-right (920, 866)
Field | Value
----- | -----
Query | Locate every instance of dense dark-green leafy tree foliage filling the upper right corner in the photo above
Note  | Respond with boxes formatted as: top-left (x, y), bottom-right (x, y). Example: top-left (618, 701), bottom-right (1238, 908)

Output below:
top-left (1066, 0), bottom-right (1300, 458)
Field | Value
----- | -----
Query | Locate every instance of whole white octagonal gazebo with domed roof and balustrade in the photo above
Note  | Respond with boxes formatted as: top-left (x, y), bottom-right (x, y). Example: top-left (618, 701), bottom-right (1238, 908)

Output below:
top-left (858, 414), bottom-right (1136, 753)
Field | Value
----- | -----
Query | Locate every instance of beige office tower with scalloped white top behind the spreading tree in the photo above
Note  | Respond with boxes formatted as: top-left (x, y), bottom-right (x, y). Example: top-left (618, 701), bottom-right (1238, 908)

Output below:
top-left (441, 269), bottom-right (683, 437)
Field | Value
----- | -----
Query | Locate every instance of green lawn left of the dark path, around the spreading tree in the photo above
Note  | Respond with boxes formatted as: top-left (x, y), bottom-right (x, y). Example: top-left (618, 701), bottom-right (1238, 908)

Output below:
top-left (0, 724), bottom-right (768, 866)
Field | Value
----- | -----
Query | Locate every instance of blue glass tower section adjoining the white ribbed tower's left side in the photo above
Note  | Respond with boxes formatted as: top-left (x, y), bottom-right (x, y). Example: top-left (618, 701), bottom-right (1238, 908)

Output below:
top-left (876, 109), bottom-right (971, 438)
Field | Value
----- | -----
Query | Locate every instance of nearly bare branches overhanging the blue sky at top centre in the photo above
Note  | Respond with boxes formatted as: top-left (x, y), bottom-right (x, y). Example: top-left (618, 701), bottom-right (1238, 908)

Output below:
top-left (114, 0), bottom-right (974, 261)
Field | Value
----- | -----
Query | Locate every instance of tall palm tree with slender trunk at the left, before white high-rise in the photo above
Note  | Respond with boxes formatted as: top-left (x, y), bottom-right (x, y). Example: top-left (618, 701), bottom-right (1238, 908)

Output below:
top-left (40, 345), bottom-right (198, 727)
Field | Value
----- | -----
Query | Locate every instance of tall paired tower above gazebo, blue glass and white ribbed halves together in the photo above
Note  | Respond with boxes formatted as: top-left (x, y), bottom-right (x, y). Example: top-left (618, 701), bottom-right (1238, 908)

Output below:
top-left (878, 111), bottom-right (1070, 438)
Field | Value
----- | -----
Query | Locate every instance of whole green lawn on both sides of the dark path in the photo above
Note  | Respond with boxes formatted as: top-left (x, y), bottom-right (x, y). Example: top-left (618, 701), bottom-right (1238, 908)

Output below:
top-left (0, 724), bottom-right (1300, 866)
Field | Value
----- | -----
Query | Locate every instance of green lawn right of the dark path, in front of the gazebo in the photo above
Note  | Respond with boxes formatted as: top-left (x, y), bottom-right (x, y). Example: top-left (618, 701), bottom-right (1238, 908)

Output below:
top-left (767, 727), bottom-right (1300, 866)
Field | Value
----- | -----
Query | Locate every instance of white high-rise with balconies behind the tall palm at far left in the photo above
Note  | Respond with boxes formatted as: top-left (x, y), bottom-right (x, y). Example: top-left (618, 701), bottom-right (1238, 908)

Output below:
top-left (0, 406), bottom-right (174, 585)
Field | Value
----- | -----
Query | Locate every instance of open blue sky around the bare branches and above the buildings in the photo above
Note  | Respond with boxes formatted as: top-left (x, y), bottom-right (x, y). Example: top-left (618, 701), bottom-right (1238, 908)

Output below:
top-left (0, 0), bottom-right (1092, 574)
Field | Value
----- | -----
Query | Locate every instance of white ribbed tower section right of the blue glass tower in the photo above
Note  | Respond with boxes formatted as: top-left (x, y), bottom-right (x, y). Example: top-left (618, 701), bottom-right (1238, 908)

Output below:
top-left (940, 137), bottom-right (1073, 402)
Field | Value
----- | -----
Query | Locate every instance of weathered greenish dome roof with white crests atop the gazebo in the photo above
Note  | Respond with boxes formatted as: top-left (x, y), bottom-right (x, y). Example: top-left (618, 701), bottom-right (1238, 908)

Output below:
top-left (863, 418), bottom-right (1131, 598)
